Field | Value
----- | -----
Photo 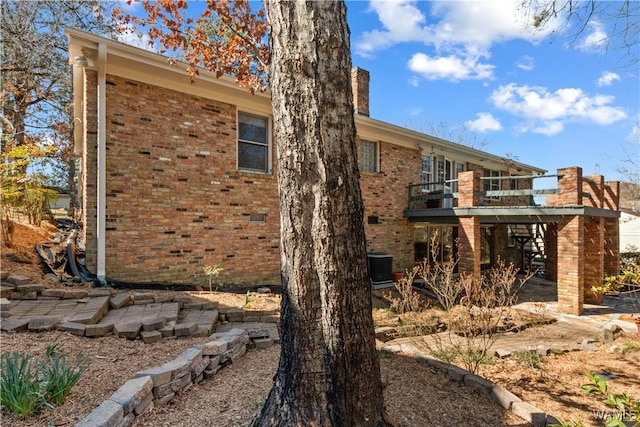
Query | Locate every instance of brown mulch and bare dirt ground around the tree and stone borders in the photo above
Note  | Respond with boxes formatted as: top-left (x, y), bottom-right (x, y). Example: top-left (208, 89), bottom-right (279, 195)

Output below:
top-left (0, 219), bottom-right (640, 427)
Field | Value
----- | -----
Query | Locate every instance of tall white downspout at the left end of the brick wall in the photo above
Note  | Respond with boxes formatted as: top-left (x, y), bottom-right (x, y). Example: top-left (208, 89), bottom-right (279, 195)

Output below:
top-left (96, 43), bottom-right (107, 284)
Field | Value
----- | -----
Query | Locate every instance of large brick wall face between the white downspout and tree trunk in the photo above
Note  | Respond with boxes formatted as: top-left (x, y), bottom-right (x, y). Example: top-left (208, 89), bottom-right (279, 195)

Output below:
top-left (100, 76), bottom-right (280, 284)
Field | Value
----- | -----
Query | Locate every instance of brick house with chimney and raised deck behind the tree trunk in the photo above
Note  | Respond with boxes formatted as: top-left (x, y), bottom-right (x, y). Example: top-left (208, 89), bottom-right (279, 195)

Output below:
top-left (67, 29), bottom-right (617, 311)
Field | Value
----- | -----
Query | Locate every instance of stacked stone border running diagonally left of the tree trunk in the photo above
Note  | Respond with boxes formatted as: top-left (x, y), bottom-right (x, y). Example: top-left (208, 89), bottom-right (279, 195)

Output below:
top-left (76, 328), bottom-right (262, 427)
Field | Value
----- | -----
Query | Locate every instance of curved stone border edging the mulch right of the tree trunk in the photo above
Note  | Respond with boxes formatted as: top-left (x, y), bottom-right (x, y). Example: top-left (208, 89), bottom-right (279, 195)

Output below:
top-left (383, 344), bottom-right (559, 427)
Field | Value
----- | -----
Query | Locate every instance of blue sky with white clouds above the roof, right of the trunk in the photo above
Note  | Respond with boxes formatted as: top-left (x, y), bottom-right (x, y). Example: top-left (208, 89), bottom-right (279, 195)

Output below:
top-left (117, 0), bottom-right (640, 180)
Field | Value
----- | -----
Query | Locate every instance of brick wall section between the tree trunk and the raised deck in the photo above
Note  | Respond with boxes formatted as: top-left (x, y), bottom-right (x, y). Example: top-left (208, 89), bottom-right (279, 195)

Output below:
top-left (360, 142), bottom-right (422, 271)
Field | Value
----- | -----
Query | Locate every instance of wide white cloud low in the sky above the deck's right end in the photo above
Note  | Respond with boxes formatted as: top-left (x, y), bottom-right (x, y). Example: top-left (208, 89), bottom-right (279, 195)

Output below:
top-left (490, 83), bottom-right (627, 135)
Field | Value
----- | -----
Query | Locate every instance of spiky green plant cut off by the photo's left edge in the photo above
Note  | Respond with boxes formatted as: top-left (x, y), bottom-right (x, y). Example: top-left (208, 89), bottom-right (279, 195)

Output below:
top-left (0, 352), bottom-right (43, 418)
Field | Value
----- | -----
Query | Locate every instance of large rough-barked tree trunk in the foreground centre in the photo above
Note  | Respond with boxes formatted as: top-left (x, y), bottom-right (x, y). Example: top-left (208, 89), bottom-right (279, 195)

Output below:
top-left (254, 0), bottom-right (384, 427)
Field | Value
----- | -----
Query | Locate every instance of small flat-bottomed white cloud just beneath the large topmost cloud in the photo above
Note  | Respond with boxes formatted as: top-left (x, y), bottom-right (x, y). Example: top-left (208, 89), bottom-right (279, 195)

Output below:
top-left (408, 53), bottom-right (495, 81)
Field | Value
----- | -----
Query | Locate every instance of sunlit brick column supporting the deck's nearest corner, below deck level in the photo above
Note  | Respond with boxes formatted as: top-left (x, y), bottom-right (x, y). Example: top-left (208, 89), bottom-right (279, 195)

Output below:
top-left (558, 215), bottom-right (584, 315)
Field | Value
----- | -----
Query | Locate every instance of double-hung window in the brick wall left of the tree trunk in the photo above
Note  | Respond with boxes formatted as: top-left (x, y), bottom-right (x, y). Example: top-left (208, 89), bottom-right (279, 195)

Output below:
top-left (238, 113), bottom-right (269, 173)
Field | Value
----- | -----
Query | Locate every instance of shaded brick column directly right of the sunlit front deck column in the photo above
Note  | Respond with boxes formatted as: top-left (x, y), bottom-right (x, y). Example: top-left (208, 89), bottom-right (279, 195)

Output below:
top-left (584, 217), bottom-right (604, 303)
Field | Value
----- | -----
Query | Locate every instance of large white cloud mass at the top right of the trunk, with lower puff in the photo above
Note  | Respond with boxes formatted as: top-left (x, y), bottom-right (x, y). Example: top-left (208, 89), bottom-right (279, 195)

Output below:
top-left (354, 0), bottom-right (553, 81)
